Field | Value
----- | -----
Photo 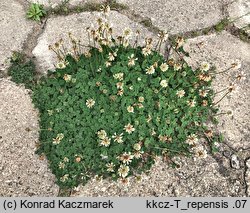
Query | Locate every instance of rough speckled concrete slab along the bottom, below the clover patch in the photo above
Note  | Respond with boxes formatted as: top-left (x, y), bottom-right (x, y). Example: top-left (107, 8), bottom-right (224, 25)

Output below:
top-left (72, 156), bottom-right (244, 197)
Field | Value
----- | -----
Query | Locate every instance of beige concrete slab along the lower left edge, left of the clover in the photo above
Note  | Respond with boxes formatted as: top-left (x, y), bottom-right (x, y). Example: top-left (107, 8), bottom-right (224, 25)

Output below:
top-left (0, 79), bottom-right (59, 197)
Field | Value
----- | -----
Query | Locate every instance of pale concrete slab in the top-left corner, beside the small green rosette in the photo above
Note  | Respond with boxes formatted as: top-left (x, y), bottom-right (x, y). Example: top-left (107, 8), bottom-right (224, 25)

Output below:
top-left (0, 0), bottom-right (34, 72)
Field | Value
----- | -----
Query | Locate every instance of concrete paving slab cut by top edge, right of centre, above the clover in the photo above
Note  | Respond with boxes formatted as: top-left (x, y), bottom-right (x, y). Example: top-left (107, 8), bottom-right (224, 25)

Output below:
top-left (117, 0), bottom-right (223, 34)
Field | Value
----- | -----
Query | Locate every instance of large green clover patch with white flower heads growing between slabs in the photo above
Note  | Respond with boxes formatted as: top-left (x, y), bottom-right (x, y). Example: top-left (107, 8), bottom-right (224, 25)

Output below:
top-left (33, 6), bottom-right (245, 188)
